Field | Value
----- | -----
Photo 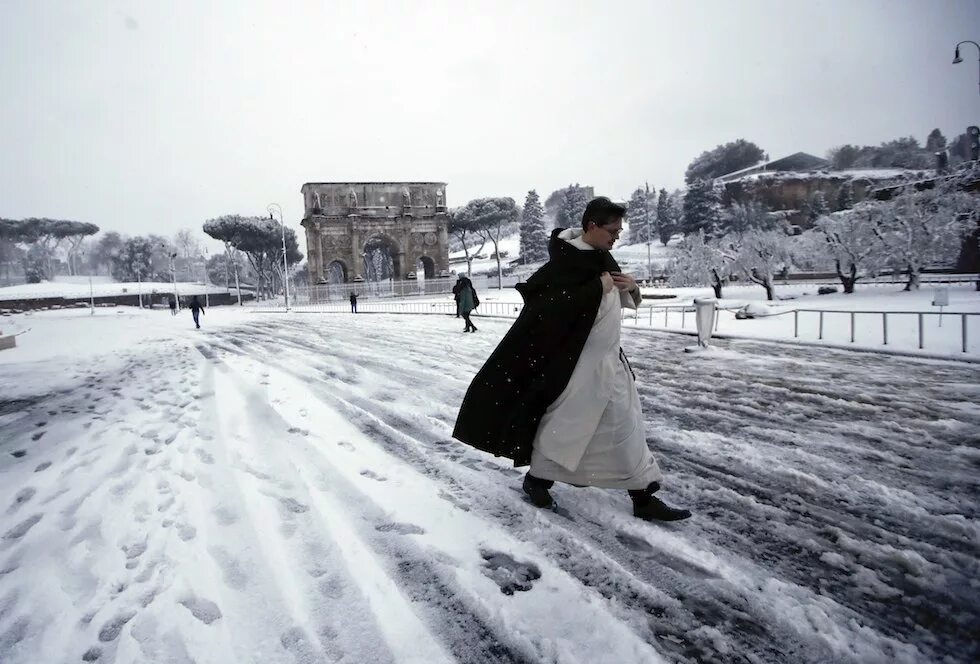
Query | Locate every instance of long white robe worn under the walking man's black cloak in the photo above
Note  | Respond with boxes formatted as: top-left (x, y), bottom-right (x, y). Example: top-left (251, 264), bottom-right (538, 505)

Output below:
top-left (531, 229), bottom-right (663, 489)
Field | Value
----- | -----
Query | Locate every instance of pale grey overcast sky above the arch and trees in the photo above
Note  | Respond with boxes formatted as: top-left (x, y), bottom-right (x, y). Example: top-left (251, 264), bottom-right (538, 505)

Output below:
top-left (0, 0), bottom-right (980, 244)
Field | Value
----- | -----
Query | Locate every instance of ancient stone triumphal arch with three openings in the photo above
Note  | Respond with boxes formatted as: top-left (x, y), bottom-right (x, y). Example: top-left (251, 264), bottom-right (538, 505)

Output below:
top-left (300, 182), bottom-right (449, 285)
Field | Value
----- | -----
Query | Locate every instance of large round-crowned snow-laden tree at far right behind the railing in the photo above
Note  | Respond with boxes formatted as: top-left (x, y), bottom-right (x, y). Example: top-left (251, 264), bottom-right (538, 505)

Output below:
top-left (875, 186), bottom-right (980, 291)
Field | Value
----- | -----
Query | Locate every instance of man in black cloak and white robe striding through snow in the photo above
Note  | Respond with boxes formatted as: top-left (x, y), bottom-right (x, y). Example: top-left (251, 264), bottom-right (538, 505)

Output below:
top-left (453, 197), bottom-right (691, 521)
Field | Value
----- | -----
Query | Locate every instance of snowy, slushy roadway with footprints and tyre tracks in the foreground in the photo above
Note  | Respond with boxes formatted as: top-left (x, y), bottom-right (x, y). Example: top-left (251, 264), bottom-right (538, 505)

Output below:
top-left (0, 307), bottom-right (980, 664)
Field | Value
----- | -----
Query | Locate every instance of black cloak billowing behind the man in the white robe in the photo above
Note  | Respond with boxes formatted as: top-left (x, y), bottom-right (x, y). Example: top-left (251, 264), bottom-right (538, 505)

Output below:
top-left (453, 228), bottom-right (619, 466)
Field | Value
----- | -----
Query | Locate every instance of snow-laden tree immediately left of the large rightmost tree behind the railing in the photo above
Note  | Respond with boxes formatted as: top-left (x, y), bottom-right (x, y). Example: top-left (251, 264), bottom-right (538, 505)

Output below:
top-left (810, 202), bottom-right (883, 293)
